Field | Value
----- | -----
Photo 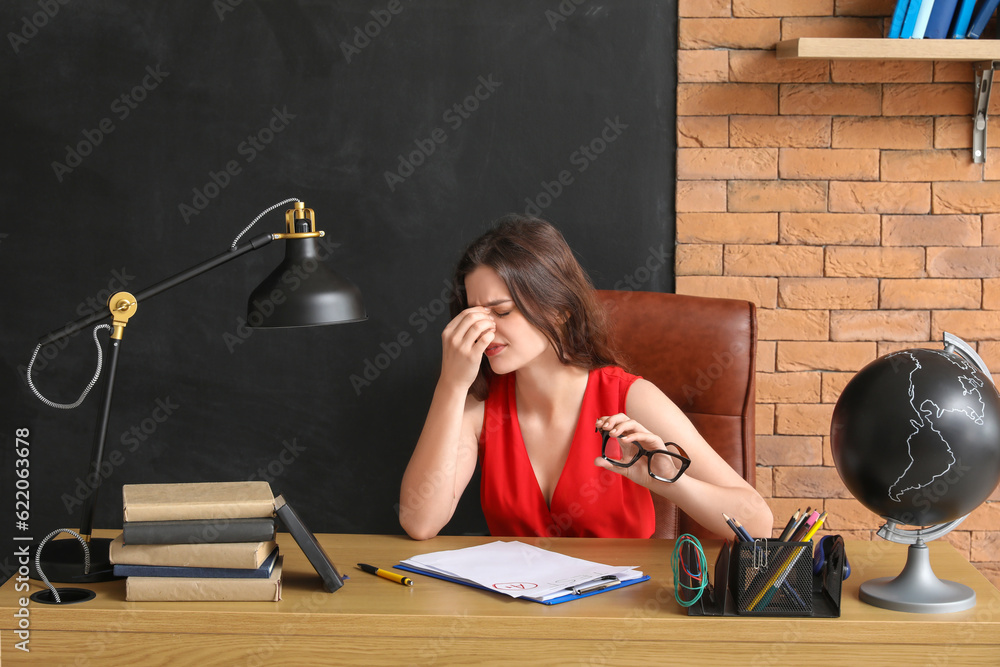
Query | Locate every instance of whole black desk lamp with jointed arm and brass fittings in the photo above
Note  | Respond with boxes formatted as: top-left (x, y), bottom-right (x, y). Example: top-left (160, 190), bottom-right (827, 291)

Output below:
top-left (28, 199), bottom-right (367, 583)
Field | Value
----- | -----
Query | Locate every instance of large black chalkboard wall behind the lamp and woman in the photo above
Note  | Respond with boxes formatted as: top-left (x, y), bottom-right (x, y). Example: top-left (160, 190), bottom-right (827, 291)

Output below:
top-left (0, 0), bottom-right (676, 573)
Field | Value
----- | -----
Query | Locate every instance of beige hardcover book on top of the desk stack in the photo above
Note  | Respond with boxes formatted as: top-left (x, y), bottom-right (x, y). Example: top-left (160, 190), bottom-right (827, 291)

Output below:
top-left (122, 482), bottom-right (274, 521)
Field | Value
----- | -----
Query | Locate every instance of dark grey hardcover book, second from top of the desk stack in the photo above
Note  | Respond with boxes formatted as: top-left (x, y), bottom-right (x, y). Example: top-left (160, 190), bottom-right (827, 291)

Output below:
top-left (122, 517), bottom-right (274, 544)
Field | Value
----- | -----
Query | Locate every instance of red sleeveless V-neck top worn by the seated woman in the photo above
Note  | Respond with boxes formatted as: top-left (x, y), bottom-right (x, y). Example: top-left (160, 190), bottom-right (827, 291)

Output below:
top-left (479, 366), bottom-right (655, 538)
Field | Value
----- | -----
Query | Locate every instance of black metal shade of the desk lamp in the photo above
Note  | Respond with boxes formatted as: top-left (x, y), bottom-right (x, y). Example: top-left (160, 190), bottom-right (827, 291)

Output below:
top-left (247, 238), bottom-right (368, 328)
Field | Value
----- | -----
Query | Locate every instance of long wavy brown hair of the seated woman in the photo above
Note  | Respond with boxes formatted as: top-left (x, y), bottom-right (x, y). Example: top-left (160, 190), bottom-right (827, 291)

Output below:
top-left (451, 214), bottom-right (623, 400)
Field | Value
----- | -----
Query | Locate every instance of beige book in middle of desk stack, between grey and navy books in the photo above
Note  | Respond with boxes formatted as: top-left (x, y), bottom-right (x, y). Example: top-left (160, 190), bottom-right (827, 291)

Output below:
top-left (109, 535), bottom-right (278, 569)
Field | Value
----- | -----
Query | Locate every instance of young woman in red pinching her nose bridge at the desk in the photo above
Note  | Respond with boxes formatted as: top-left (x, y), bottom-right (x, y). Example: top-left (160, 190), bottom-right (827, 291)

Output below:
top-left (399, 215), bottom-right (772, 539)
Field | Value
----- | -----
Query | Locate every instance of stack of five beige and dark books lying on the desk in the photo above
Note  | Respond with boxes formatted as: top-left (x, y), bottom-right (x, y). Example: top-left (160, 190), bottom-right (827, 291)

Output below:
top-left (111, 482), bottom-right (281, 601)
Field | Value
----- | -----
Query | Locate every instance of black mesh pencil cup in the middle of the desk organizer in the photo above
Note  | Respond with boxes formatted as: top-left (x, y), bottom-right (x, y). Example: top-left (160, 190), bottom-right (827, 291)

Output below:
top-left (730, 540), bottom-right (813, 616)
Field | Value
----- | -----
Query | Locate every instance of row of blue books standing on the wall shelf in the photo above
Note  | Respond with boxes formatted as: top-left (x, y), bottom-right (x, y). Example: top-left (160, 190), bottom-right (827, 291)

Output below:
top-left (889, 0), bottom-right (1000, 39)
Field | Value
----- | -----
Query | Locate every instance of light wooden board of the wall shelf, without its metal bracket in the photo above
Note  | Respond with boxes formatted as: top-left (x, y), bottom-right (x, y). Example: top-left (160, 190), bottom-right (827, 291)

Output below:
top-left (775, 37), bottom-right (1000, 62)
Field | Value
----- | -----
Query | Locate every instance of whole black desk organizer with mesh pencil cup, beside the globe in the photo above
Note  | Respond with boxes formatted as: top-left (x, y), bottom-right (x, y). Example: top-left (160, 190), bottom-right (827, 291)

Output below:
top-left (680, 536), bottom-right (846, 618)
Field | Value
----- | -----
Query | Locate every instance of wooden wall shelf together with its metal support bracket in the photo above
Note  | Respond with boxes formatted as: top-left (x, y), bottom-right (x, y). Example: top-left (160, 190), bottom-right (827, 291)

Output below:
top-left (774, 37), bottom-right (1000, 163)
